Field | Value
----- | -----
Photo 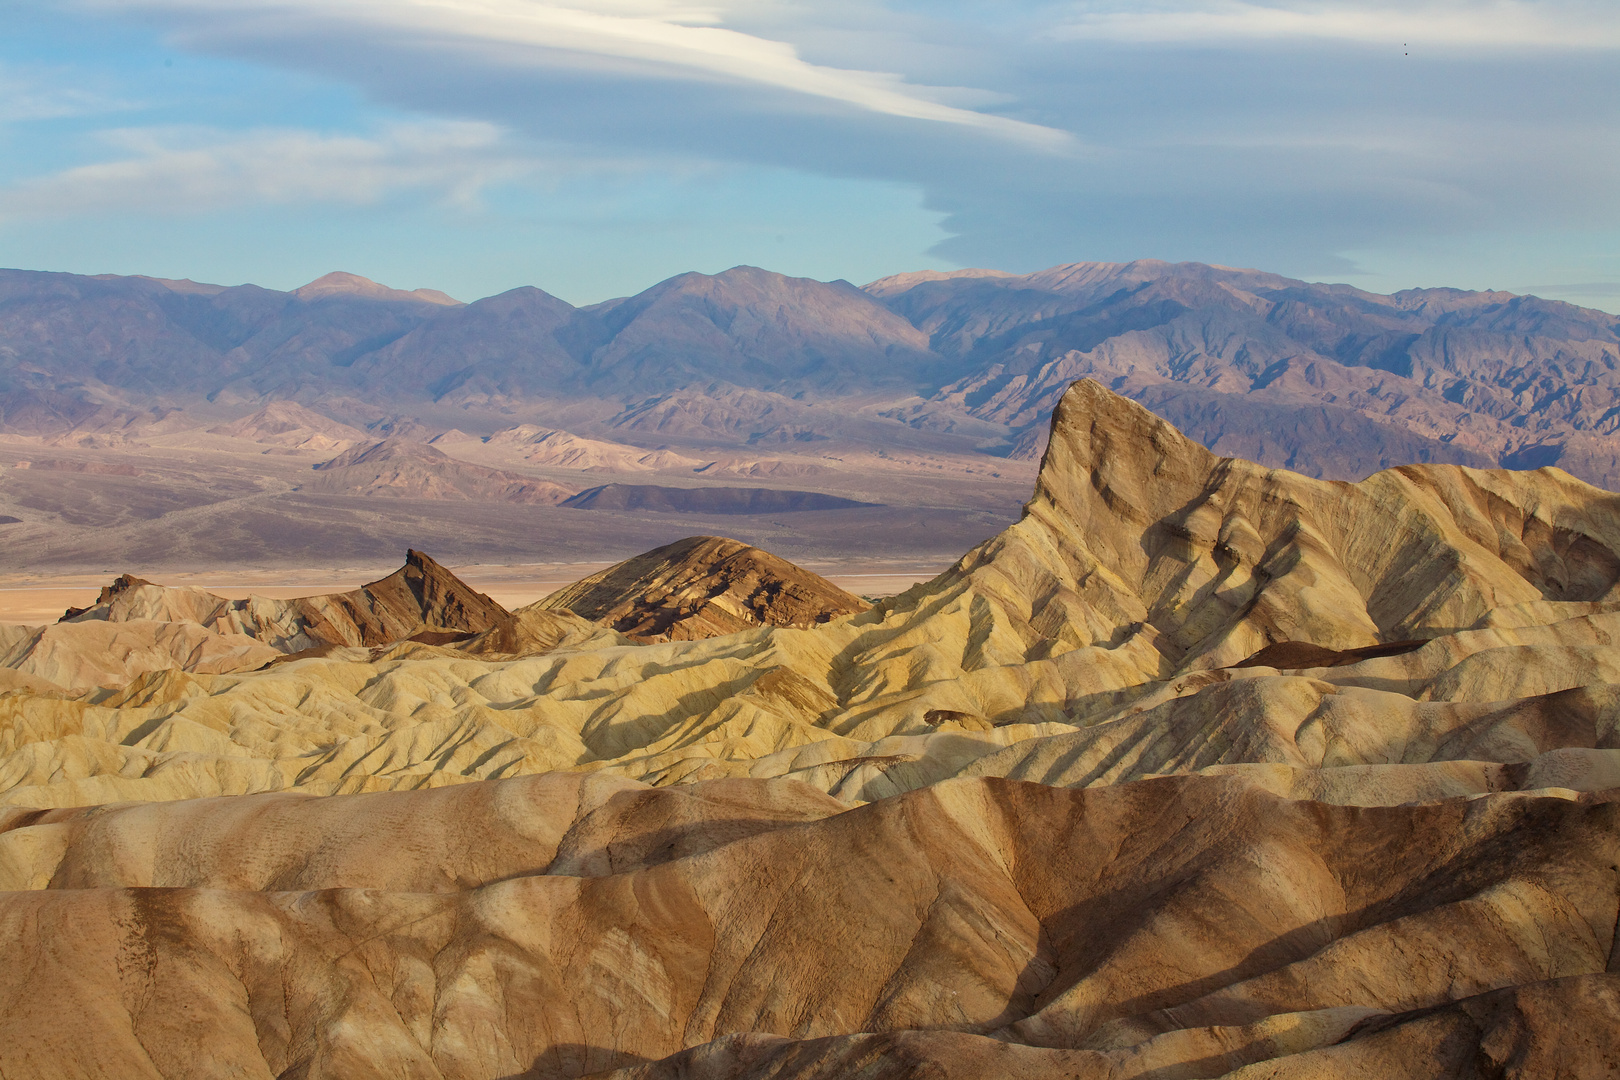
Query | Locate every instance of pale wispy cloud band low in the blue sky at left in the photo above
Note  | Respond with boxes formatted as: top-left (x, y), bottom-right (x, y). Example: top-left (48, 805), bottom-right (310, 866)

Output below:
top-left (0, 123), bottom-right (530, 217)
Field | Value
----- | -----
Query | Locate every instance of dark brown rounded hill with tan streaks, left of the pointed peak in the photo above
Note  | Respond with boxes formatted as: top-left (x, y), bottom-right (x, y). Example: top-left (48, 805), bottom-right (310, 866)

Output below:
top-left (535, 536), bottom-right (870, 641)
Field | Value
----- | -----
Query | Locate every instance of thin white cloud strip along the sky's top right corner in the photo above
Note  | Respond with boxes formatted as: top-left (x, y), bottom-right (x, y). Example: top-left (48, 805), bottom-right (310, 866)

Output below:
top-left (1055, 0), bottom-right (1620, 49)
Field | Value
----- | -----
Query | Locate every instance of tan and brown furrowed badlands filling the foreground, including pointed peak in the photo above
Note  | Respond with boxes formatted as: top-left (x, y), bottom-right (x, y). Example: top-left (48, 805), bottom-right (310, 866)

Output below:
top-left (0, 384), bottom-right (1620, 1080)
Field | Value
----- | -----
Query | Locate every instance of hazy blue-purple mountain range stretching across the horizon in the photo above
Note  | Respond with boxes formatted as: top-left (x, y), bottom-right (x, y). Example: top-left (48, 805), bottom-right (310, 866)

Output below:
top-left (0, 261), bottom-right (1620, 487)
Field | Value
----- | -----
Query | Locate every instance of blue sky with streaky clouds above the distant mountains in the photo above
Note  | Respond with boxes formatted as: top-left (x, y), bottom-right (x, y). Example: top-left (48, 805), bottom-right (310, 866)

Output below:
top-left (0, 0), bottom-right (1620, 313)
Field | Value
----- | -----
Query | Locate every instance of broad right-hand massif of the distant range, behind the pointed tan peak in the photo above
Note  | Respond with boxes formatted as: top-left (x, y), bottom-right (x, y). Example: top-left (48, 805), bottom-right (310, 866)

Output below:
top-left (867, 261), bottom-right (1620, 484)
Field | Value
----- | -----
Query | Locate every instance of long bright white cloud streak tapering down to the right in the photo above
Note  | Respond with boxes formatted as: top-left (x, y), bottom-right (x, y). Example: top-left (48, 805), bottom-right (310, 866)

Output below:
top-left (117, 0), bottom-right (1072, 149)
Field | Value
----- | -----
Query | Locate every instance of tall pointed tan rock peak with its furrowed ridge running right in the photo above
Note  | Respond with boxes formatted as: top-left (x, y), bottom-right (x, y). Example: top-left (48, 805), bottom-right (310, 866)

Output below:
top-left (935, 381), bottom-right (1620, 674)
